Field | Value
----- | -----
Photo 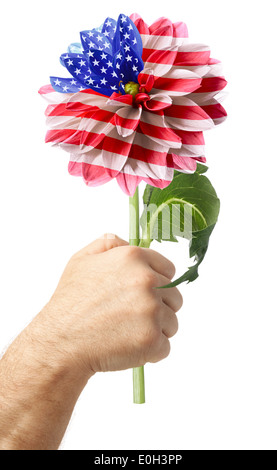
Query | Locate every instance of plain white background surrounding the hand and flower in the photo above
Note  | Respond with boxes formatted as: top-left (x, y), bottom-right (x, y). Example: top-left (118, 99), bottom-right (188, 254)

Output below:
top-left (0, 0), bottom-right (277, 450)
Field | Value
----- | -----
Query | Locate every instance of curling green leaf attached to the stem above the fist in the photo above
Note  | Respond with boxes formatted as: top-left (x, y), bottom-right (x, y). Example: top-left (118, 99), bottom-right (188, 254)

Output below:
top-left (140, 169), bottom-right (220, 287)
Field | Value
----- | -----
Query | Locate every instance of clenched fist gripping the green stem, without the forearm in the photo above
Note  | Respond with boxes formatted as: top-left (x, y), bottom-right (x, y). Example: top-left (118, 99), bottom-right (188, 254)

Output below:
top-left (30, 236), bottom-right (182, 375)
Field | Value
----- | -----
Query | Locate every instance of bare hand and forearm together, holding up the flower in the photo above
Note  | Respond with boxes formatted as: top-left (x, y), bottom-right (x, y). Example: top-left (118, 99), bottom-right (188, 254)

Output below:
top-left (0, 235), bottom-right (182, 450)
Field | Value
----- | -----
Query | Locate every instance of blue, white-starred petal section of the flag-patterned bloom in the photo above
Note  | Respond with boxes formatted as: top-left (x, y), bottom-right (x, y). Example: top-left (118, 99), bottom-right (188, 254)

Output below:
top-left (48, 15), bottom-right (144, 96)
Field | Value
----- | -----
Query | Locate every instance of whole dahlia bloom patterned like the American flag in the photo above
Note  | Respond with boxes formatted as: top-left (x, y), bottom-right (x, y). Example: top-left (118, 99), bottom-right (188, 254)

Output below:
top-left (39, 14), bottom-right (226, 195)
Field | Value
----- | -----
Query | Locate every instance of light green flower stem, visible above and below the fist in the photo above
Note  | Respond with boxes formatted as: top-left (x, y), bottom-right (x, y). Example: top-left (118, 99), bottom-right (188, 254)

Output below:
top-left (129, 187), bottom-right (145, 404)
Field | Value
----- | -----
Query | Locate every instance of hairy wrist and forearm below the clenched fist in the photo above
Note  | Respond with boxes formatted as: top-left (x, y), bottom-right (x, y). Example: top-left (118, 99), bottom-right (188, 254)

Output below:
top-left (0, 318), bottom-right (92, 450)
